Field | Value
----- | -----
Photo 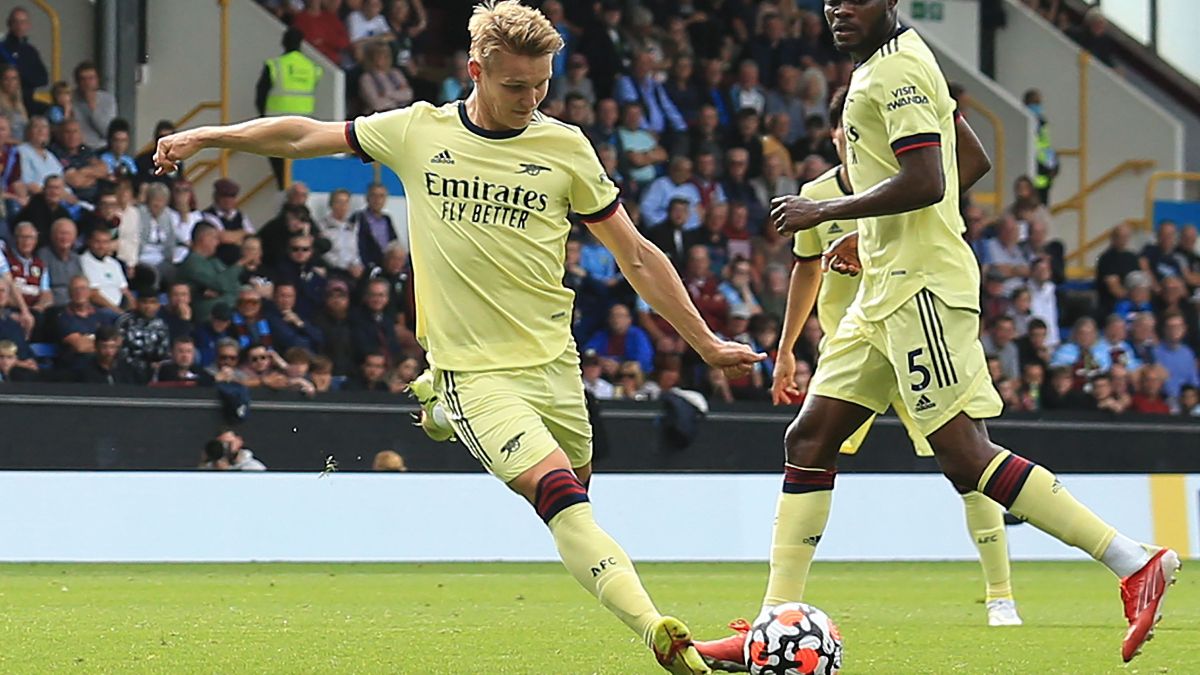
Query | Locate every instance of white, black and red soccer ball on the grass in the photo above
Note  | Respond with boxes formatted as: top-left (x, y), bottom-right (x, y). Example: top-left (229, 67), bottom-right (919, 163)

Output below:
top-left (744, 603), bottom-right (841, 675)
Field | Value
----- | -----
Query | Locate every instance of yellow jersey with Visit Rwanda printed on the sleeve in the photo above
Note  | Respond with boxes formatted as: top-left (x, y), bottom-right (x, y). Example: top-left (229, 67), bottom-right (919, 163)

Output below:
top-left (842, 28), bottom-right (979, 321)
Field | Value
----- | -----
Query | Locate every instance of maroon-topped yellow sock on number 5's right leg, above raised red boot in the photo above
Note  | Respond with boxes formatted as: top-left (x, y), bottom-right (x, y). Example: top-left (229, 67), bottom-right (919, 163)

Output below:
top-left (978, 450), bottom-right (1116, 560)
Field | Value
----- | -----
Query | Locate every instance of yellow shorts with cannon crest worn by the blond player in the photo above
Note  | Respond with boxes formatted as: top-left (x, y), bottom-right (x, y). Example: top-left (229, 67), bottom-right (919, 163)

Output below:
top-left (434, 342), bottom-right (592, 483)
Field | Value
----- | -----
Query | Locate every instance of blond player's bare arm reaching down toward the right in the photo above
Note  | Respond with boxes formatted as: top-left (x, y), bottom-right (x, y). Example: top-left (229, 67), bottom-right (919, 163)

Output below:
top-left (588, 201), bottom-right (767, 377)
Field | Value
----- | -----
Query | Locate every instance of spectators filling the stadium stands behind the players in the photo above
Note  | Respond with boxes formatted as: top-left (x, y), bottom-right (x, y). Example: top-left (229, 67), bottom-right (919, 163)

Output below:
top-left (0, 0), bottom-right (1200, 416)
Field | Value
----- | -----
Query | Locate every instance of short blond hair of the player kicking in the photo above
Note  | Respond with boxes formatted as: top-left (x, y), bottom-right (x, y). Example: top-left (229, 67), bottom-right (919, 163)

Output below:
top-left (467, 0), bottom-right (563, 64)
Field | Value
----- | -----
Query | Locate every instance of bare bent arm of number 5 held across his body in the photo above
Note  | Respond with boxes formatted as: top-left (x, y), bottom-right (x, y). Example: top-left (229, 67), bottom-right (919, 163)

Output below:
top-left (770, 145), bottom-right (946, 234)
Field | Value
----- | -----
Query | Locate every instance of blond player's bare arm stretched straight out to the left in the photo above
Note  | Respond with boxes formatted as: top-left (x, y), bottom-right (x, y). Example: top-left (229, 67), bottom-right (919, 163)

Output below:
top-left (154, 115), bottom-right (353, 174)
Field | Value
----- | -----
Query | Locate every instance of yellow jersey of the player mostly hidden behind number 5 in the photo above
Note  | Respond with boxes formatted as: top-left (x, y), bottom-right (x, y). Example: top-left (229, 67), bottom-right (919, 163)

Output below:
top-left (792, 166), bottom-right (859, 335)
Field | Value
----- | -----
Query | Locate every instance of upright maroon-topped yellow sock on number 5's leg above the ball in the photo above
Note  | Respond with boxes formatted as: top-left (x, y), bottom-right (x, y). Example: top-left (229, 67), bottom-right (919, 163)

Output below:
top-left (762, 466), bottom-right (834, 607)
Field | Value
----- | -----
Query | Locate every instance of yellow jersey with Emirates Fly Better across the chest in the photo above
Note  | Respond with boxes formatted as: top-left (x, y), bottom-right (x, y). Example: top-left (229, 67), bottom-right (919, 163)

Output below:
top-left (346, 102), bottom-right (618, 371)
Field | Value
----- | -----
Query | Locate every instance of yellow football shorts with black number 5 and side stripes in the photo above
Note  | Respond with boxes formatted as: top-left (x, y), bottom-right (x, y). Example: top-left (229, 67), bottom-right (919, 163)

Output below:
top-left (810, 291), bottom-right (1003, 437)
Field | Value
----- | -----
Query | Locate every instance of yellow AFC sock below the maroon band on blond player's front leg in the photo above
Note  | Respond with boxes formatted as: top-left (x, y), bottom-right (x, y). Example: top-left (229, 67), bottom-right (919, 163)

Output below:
top-left (547, 502), bottom-right (662, 646)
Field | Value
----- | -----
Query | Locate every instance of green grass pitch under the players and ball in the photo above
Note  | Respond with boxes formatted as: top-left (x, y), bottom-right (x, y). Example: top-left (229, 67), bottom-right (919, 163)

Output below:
top-left (0, 562), bottom-right (1200, 675)
